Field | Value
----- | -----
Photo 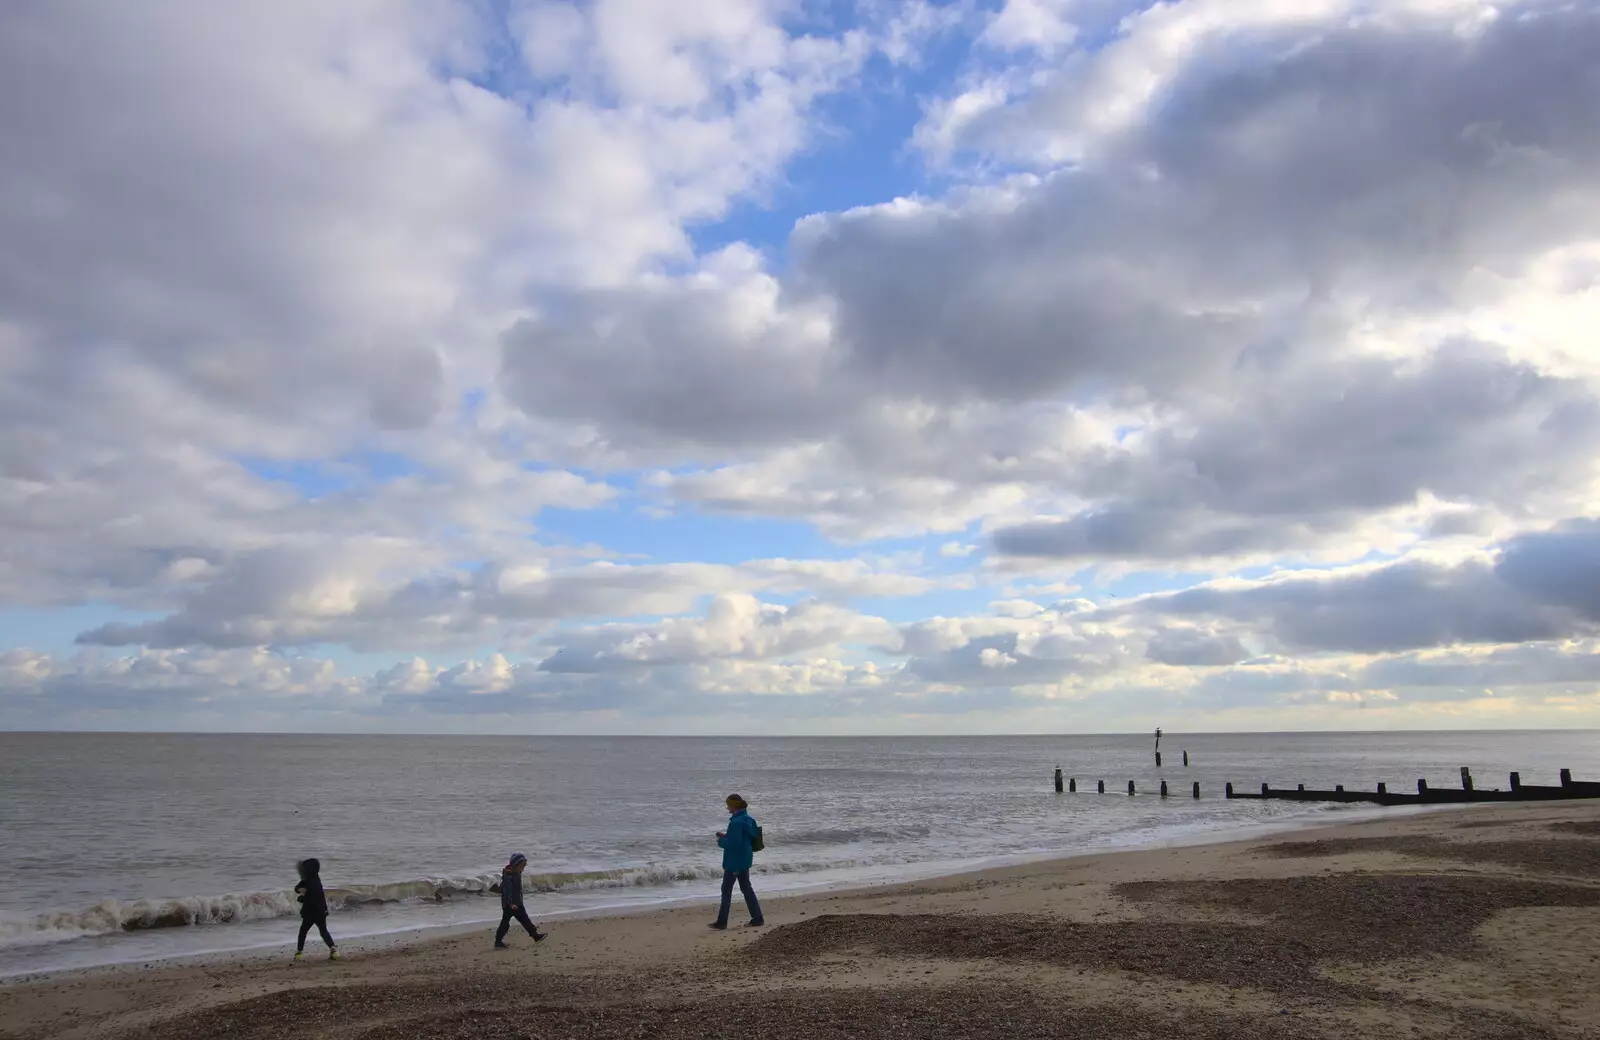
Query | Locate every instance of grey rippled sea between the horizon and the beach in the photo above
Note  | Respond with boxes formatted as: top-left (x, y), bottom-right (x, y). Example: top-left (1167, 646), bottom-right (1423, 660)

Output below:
top-left (0, 731), bottom-right (1600, 978)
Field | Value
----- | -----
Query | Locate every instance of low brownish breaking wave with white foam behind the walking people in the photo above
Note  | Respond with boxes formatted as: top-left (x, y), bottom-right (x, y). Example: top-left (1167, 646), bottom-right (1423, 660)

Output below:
top-left (0, 862), bottom-right (861, 946)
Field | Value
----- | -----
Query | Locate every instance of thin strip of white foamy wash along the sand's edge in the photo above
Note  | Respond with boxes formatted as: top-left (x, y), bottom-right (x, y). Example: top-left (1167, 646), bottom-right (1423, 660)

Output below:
top-left (0, 793), bottom-right (1482, 979)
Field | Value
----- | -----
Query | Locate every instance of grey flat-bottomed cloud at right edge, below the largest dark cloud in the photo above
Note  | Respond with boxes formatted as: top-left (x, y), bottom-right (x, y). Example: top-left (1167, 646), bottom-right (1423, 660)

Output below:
top-left (994, 344), bottom-right (1600, 560)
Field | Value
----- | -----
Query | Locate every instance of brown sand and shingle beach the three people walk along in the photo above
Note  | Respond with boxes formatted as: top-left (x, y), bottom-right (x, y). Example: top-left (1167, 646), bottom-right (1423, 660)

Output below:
top-left (0, 802), bottom-right (1600, 1040)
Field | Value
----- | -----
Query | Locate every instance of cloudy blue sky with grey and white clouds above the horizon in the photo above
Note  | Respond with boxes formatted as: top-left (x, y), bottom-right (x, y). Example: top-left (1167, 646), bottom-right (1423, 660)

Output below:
top-left (0, 0), bottom-right (1600, 734)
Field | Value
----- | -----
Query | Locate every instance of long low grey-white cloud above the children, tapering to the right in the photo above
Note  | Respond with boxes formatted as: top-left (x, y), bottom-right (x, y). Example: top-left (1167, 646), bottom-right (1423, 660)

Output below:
top-left (68, 550), bottom-right (947, 651)
